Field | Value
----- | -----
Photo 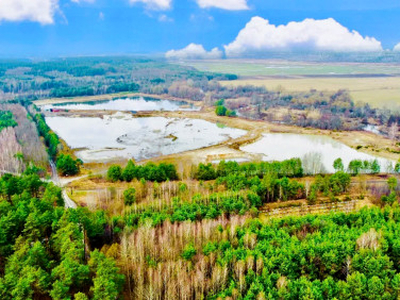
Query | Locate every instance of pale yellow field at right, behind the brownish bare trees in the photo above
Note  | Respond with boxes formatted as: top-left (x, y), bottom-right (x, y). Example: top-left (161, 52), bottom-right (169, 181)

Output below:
top-left (221, 77), bottom-right (400, 110)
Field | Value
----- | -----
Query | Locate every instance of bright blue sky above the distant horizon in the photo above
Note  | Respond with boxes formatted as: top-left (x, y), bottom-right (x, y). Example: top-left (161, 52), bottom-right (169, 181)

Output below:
top-left (0, 0), bottom-right (400, 57)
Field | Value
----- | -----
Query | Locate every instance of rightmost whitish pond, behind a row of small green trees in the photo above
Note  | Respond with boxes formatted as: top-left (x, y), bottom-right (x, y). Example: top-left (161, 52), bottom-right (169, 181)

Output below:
top-left (241, 133), bottom-right (393, 174)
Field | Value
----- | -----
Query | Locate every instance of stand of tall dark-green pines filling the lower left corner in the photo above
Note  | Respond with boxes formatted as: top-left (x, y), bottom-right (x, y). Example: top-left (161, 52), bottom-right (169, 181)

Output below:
top-left (0, 170), bottom-right (124, 299)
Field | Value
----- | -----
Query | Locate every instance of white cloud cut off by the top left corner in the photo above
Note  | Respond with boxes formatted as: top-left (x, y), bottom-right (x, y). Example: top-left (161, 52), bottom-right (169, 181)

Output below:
top-left (0, 0), bottom-right (58, 25)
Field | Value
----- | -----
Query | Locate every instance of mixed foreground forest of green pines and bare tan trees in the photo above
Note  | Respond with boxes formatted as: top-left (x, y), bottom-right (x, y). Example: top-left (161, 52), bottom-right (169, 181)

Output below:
top-left (0, 159), bottom-right (400, 299)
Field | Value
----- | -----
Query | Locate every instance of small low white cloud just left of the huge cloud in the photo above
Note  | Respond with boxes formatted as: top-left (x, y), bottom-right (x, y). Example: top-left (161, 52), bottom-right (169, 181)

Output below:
top-left (165, 43), bottom-right (222, 59)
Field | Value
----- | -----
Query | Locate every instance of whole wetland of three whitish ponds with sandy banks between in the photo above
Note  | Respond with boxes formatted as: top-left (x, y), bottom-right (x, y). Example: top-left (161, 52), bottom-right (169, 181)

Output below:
top-left (42, 97), bottom-right (394, 173)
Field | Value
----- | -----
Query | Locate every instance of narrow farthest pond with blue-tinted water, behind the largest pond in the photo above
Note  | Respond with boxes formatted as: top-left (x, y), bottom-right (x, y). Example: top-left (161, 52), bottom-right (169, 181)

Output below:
top-left (42, 97), bottom-right (200, 111)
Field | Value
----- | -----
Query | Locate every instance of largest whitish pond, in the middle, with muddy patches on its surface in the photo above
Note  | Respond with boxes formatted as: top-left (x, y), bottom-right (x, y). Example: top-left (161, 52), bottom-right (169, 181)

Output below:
top-left (46, 112), bottom-right (246, 162)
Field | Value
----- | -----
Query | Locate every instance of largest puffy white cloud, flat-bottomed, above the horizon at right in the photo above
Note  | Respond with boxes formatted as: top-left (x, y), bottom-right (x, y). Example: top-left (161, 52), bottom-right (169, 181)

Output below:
top-left (224, 17), bottom-right (382, 57)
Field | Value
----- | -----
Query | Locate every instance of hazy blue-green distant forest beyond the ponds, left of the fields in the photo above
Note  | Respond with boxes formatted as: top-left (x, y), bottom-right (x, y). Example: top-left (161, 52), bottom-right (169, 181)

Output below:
top-left (0, 57), bottom-right (237, 101)
